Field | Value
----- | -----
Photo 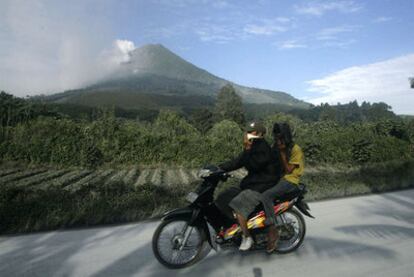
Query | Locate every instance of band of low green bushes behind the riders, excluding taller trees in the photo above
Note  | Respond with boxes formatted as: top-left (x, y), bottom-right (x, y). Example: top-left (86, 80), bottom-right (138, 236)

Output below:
top-left (0, 111), bottom-right (414, 167)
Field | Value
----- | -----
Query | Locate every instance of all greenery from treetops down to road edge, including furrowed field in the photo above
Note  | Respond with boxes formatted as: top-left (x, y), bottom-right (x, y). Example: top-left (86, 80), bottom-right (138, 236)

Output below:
top-left (0, 87), bottom-right (414, 232)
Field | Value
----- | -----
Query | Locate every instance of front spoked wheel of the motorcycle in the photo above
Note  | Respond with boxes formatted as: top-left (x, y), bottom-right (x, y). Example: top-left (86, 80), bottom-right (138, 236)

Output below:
top-left (152, 218), bottom-right (206, 268)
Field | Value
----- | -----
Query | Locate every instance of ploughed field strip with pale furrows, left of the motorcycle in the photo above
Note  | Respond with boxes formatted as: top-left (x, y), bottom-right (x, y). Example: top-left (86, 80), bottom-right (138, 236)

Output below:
top-left (0, 167), bottom-right (245, 191)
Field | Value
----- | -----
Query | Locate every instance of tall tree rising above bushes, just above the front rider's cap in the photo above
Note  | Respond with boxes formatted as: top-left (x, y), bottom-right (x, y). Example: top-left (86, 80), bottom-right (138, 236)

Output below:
top-left (214, 84), bottom-right (245, 125)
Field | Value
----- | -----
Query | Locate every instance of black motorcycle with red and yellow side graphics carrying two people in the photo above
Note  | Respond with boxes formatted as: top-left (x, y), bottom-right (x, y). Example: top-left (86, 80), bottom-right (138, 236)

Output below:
top-left (152, 166), bottom-right (314, 269)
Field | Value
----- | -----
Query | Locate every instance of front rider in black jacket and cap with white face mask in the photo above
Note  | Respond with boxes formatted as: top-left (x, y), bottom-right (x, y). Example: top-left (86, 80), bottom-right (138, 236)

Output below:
top-left (215, 122), bottom-right (281, 227)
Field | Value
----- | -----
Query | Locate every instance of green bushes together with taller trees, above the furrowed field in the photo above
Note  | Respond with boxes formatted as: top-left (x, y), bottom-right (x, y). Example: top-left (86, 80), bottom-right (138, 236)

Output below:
top-left (0, 87), bottom-right (414, 167)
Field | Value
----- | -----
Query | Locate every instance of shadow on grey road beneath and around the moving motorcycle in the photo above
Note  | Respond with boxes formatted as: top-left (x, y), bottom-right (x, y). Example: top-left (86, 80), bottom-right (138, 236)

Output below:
top-left (89, 233), bottom-right (395, 277)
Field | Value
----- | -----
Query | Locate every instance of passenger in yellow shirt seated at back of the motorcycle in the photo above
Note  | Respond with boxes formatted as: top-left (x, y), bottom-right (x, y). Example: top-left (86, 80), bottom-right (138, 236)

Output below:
top-left (230, 123), bottom-right (304, 253)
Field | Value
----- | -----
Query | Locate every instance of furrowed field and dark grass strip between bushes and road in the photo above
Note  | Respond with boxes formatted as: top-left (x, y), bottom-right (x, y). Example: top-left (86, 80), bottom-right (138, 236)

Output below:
top-left (0, 160), bottom-right (414, 233)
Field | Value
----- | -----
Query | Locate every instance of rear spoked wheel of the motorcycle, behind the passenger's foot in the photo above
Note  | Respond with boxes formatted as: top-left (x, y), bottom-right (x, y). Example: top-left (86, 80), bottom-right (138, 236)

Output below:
top-left (276, 208), bottom-right (306, 254)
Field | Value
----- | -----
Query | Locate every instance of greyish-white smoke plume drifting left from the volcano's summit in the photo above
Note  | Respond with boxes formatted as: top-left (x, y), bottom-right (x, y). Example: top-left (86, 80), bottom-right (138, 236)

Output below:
top-left (0, 0), bottom-right (135, 96)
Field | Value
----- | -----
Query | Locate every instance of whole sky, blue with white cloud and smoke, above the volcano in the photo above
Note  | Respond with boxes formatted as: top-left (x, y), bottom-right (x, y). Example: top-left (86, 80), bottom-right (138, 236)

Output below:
top-left (0, 0), bottom-right (414, 114)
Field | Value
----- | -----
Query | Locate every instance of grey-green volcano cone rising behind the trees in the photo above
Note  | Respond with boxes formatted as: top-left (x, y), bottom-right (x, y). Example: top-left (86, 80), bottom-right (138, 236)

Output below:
top-left (47, 44), bottom-right (309, 108)
